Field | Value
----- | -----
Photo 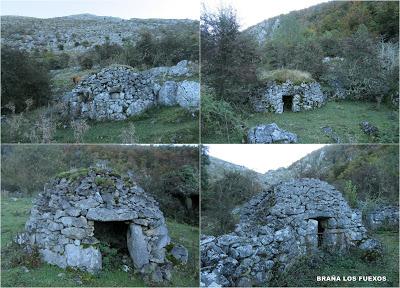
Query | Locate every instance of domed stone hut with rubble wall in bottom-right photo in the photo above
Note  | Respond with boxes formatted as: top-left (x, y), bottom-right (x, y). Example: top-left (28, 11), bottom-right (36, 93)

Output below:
top-left (200, 178), bottom-right (381, 287)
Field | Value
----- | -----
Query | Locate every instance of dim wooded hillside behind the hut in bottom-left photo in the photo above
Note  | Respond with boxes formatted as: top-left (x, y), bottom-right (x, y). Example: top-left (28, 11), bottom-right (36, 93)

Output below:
top-left (1, 145), bottom-right (199, 225)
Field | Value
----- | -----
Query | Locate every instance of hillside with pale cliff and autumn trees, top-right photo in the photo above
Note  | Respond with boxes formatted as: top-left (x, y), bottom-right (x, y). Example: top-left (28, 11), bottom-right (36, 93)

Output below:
top-left (244, 1), bottom-right (399, 44)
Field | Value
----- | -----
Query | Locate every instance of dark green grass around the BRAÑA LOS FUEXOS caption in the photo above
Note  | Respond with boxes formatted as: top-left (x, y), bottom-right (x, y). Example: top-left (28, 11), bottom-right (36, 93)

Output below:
top-left (272, 232), bottom-right (399, 287)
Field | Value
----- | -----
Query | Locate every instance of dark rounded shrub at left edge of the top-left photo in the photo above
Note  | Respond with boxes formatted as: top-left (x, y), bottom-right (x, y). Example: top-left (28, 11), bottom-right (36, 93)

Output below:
top-left (1, 47), bottom-right (51, 113)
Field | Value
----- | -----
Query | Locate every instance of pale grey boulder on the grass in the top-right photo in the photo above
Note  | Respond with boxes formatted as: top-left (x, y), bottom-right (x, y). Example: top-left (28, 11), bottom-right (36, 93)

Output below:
top-left (247, 123), bottom-right (297, 144)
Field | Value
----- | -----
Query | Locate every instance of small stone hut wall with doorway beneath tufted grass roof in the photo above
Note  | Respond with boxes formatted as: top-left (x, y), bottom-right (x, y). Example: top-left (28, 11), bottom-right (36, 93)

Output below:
top-left (253, 80), bottom-right (326, 114)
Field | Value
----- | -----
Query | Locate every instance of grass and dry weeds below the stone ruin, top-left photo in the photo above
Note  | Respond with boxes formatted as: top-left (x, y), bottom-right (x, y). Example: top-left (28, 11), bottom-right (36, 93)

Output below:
top-left (1, 107), bottom-right (199, 143)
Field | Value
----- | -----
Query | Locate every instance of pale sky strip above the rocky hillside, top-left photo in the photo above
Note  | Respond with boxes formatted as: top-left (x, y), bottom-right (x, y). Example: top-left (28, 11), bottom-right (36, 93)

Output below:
top-left (0, 0), bottom-right (200, 20)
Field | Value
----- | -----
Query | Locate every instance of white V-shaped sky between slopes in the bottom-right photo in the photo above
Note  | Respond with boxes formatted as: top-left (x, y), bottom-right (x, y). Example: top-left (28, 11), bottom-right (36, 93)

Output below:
top-left (206, 144), bottom-right (326, 173)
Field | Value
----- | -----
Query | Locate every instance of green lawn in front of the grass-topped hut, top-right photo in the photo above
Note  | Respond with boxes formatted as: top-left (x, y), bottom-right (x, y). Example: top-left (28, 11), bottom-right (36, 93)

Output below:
top-left (202, 101), bottom-right (399, 143)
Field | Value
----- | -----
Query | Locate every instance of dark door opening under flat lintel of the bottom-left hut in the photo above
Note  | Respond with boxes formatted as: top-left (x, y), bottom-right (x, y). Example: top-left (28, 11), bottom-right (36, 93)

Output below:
top-left (94, 221), bottom-right (129, 254)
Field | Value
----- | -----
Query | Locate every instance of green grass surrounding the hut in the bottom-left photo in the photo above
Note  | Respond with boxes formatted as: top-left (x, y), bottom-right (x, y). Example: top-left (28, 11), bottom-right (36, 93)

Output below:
top-left (1, 197), bottom-right (199, 287)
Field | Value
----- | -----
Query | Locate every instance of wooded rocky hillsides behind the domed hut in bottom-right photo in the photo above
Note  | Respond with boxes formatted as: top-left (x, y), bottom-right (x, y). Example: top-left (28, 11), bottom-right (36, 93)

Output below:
top-left (201, 145), bottom-right (399, 235)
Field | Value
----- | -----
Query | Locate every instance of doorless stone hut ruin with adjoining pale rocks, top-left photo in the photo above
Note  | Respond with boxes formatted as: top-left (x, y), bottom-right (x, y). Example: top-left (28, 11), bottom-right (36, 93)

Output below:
top-left (63, 60), bottom-right (200, 120)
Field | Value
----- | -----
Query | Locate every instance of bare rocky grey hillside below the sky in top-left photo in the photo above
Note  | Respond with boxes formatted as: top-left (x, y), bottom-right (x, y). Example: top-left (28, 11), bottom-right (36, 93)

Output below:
top-left (1, 14), bottom-right (198, 52)
